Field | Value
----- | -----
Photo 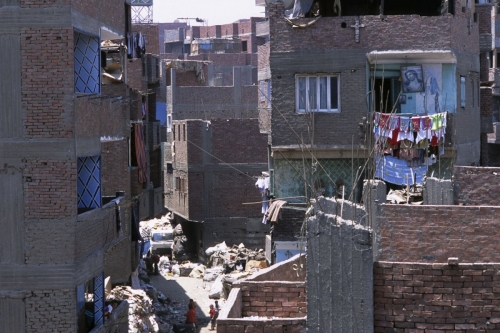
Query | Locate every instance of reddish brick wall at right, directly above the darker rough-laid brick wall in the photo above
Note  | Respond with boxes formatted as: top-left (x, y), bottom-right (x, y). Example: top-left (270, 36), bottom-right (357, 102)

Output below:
top-left (379, 204), bottom-right (500, 262)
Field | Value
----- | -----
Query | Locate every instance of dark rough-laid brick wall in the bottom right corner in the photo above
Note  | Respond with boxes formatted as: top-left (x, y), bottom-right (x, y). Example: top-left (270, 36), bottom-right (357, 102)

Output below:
top-left (374, 262), bottom-right (500, 333)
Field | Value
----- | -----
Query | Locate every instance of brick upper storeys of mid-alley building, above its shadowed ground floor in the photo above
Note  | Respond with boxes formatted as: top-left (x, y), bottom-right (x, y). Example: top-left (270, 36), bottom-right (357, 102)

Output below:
top-left (166, 119), bottom-right (267, 219)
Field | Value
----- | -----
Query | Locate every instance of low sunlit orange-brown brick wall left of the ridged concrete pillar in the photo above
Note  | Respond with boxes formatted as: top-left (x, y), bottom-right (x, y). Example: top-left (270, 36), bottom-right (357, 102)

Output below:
top-left (241, 281), bottom-right (307, 318)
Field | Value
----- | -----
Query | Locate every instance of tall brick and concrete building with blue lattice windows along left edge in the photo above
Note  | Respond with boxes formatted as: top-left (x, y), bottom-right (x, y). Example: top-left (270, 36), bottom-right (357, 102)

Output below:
top-left (0, 0), bottom-right (158, 332)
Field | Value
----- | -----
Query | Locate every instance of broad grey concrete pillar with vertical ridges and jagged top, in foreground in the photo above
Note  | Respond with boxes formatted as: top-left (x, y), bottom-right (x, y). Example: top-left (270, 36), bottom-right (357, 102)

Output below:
top-left (306, 197), bottom-right (373, 333)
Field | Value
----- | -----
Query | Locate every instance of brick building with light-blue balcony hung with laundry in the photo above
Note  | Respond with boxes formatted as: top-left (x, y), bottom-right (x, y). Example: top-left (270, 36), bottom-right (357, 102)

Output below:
top-left (264, 0), bottom-right (481, 201)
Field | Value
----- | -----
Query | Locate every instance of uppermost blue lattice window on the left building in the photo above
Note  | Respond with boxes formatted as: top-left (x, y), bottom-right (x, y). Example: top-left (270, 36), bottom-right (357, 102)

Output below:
top-left (74, 31), bottom-right (101, 94)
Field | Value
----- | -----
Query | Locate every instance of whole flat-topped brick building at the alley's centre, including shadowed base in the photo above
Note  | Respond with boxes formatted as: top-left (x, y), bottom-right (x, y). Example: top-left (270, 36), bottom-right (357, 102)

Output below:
top-left (165, 115), bottom-right (268, 259)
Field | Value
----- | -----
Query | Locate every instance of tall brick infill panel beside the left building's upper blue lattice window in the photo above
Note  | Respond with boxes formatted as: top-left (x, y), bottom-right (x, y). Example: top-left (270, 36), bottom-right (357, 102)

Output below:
top-left (21, 26), bottom-right (74, 138)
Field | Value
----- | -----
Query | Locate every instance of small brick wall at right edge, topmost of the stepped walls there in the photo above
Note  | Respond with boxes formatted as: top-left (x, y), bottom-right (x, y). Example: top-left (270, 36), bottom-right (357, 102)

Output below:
top-left (454, 166), bottom-right (500, 204)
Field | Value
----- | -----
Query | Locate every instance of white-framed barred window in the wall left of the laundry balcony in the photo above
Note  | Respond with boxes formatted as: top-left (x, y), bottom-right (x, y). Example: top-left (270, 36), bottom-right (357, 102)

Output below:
top-left (295, 75), bottom-right (340, 113)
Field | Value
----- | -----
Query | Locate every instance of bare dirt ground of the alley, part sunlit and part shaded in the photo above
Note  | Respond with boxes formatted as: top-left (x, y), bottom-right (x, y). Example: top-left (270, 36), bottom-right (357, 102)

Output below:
top-left (150, 275), bottom-right (224, 333)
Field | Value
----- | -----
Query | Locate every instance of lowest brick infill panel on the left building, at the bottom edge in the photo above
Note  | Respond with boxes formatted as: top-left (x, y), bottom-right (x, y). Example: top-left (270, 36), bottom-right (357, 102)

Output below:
top-left (25, 289), bottom-right (77, 333)
